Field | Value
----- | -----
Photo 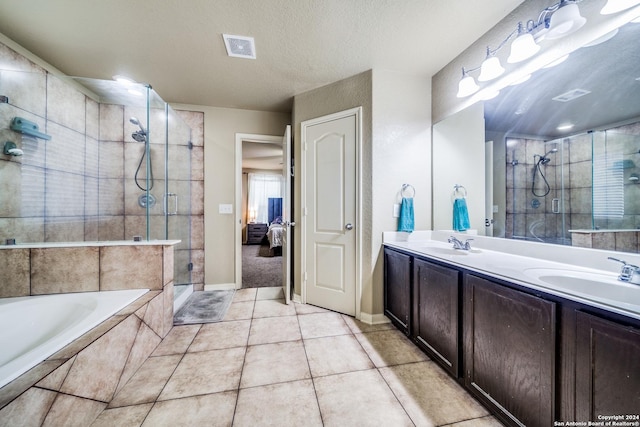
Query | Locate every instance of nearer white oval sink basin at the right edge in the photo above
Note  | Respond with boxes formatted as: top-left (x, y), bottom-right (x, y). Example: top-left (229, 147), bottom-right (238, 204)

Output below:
top-left (524, 268), bottom-right (640, 305)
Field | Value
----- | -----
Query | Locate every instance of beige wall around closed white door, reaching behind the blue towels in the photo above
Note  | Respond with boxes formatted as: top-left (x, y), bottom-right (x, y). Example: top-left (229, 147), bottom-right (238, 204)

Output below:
top-left (293, 70), bottom-right (431, 321)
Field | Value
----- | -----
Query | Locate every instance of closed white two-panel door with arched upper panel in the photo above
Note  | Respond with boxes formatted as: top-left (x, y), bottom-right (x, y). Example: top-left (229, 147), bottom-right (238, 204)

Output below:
top-left (302, 113), bottom-right (360, 316)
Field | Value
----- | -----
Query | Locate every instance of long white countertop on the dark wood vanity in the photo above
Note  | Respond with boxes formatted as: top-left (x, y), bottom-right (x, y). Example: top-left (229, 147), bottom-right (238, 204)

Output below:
top-left (383, 231), bottom-right (640, 320)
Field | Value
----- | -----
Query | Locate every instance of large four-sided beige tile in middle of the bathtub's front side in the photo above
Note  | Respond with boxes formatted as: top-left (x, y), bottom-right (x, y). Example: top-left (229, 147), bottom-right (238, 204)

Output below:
top-left (60, 316), bottom-right (140, 402)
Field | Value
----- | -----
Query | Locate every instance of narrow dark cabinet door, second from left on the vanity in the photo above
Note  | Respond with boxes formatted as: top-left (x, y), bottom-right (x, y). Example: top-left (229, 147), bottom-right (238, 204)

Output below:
top-left (413, 259), bottom-right (460, 377)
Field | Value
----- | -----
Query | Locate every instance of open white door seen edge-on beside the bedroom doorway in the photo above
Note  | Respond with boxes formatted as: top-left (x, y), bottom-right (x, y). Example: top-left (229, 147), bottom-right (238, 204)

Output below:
top-left (282, 125), bottom-right (295, 304)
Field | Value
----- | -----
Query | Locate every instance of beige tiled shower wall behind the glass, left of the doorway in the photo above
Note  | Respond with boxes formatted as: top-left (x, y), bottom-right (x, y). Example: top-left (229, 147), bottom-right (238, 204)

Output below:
top-left (0, 43), bottom-right (204, 289)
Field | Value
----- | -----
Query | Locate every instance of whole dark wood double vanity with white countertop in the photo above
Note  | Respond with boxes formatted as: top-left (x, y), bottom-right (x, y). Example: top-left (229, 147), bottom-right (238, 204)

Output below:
top-left (384, 232), bottom-right (640, 426)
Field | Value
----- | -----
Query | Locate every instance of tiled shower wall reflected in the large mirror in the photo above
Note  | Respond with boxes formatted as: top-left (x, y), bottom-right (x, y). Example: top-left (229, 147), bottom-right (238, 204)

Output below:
top-left (506, 123), bottom-right (640, 249)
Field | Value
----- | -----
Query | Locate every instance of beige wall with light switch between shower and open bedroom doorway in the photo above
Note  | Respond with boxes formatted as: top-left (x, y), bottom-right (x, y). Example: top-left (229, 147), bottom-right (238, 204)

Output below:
top-left (172, 104), bottom-right (291, 284)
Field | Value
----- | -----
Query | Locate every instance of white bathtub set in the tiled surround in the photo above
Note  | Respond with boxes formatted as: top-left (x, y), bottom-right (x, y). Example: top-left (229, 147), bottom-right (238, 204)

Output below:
top-left (0, 289), bottom-right (148, 387)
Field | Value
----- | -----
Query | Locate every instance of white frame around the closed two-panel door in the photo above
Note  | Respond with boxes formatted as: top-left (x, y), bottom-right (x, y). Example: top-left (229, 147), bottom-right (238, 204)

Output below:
top-left (299, 107), bottom-right (363, 319)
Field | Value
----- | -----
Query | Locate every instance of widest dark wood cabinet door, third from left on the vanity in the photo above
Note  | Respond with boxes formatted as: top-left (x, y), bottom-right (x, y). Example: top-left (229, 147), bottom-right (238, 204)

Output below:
top-left (463, 275), bottom-right (556, 427)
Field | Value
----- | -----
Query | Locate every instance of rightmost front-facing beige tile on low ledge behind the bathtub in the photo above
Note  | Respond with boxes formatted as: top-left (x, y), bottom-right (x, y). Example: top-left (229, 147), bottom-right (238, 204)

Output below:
top-left (100, 245), bottom-right (162, 291)
